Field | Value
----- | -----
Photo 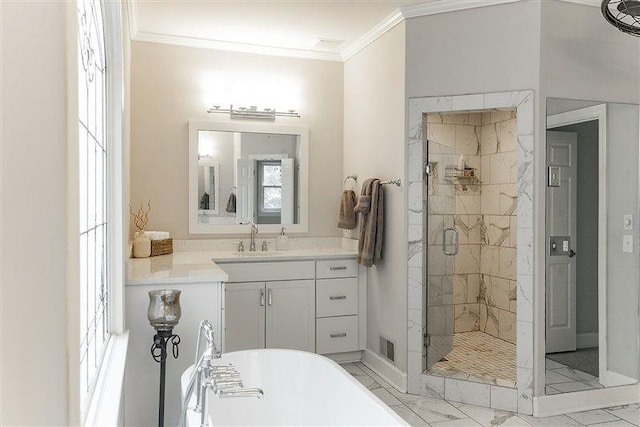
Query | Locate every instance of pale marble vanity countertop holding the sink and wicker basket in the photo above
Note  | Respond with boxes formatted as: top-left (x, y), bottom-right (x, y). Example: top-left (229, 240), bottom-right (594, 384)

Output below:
top-left (126, 247), bottom-right (357, 286)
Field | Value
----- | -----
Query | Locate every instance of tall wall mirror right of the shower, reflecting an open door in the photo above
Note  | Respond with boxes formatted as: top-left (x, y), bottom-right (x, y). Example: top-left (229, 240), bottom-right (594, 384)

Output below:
top-left (545, 98), bottom-right (640, 395)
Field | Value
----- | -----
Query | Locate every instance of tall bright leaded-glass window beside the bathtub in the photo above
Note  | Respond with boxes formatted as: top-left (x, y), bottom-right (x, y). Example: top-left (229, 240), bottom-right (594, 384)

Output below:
top-left (77, 0), bottom-right (111, 411)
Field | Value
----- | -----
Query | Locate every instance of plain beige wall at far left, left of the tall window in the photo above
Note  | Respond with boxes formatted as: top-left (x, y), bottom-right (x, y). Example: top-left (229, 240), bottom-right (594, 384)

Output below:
top-left (0, 2), bottom-right (69, 425)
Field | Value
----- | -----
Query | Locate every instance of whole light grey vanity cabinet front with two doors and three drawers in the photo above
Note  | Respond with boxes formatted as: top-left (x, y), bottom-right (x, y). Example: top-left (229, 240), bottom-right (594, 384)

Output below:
top-left (217, 257), bottom-right (366, 360)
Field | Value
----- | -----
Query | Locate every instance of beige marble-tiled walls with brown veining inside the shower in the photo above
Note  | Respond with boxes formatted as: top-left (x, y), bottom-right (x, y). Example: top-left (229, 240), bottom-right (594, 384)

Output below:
top-left (426, 111), bottom-right (517, 343)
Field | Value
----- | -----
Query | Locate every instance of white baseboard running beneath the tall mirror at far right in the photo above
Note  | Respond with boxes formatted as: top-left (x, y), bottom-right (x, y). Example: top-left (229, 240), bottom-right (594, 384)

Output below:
top-left (533, 384), bottom-right (640, 417)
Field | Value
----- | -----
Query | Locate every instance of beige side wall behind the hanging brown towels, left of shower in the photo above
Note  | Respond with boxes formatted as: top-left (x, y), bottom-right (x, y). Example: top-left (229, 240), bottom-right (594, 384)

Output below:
top-left (343, 22), bottom-right (407, 371)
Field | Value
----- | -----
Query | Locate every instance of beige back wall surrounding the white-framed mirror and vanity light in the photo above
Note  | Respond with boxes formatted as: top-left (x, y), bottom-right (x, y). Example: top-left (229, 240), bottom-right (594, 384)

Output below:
top-left (131, 42), bottom-right (343, 239)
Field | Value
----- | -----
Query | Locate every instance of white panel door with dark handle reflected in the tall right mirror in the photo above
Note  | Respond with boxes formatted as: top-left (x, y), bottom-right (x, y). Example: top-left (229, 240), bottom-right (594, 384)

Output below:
top-left (546, 131), bottom-right (578, 353)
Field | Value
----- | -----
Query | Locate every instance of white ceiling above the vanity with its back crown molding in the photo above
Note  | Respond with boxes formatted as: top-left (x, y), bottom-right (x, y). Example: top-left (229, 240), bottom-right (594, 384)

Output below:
top-left (128, 0), bottom-right (422, 61)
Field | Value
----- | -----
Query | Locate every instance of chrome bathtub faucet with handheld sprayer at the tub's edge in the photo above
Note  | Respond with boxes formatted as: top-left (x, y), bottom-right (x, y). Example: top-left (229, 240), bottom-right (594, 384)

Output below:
top-left (178, 320), bottom-right (264, 427)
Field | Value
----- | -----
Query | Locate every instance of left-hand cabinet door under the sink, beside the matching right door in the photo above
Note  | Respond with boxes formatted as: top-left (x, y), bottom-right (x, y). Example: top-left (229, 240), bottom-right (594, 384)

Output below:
top-left (224, 282), bottom-right (267, 352)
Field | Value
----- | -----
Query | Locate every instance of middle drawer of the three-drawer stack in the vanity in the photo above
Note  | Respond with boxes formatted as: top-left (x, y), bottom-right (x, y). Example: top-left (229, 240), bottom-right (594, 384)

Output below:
top-left (316, 277), bottom-right (358, 317)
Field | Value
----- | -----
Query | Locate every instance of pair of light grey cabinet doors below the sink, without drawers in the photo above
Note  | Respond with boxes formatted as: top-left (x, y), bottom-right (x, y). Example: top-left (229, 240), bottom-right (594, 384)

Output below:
top-left (224, 280), bottom-right (315, 352)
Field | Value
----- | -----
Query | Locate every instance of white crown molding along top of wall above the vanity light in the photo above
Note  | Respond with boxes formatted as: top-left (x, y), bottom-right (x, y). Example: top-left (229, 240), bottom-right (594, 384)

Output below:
top-left (132, 31), bottom-right (342, 62)
